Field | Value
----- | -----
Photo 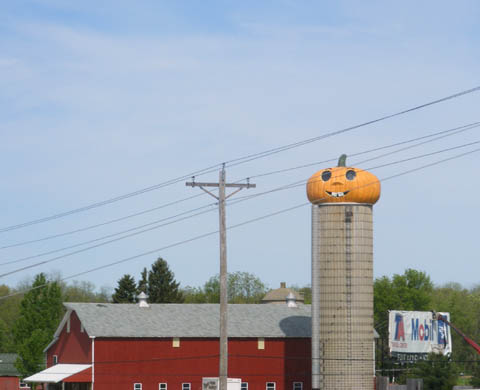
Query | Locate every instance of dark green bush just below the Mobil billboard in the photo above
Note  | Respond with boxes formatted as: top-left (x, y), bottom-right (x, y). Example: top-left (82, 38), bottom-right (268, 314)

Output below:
top-left (409, 353), bottom-right (458, 390)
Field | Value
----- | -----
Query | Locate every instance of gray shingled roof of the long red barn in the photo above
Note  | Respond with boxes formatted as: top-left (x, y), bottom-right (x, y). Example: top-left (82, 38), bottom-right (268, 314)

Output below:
top-left (65, 303), bottom-right (312, 337)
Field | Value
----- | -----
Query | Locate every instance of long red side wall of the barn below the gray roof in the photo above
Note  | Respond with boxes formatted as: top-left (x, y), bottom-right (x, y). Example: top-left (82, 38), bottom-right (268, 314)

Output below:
top-left (95, 338), bottom-right (311, 390)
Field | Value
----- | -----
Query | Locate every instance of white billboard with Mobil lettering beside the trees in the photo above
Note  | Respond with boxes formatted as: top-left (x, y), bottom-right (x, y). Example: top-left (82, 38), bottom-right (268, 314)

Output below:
top-left (388, 310), bottom-right (452, 361)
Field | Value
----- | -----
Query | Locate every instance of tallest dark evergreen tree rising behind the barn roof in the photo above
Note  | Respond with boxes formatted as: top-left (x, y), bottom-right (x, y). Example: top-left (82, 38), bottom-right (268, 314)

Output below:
top-left (147, 257), bottom-right (184, 303)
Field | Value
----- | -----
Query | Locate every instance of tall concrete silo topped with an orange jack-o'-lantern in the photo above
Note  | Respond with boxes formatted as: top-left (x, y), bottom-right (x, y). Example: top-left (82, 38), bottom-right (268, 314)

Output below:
top-left (307, 155), bottom-right (380, 390)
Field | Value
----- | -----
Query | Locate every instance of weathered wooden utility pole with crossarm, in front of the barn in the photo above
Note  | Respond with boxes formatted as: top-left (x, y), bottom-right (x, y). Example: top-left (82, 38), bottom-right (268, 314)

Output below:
top-left (185, 164), bottom-right (256, 390)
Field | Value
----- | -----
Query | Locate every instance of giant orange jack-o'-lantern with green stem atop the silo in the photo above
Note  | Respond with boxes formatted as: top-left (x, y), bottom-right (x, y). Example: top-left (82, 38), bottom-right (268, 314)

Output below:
top-left (307, 154), bottom-right (380, 204)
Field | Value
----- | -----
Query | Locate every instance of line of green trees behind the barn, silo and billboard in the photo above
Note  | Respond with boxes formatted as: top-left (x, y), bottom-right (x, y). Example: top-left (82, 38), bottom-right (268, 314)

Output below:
top-left (0, 258), bottom-right (480, 389)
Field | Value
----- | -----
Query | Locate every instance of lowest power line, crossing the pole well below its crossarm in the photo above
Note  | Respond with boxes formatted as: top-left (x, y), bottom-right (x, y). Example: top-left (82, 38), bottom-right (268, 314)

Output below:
top-left (0, 148), bottom-right (480, 301)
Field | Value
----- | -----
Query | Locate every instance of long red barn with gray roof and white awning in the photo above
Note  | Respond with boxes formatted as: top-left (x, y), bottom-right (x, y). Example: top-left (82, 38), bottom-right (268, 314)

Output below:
top-left (26, 303), bottom-right (311, 390)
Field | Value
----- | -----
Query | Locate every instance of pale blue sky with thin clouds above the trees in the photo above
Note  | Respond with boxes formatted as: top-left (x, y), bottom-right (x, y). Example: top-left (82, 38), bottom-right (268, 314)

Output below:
top-left (0, 0), bottom-right (480, 287)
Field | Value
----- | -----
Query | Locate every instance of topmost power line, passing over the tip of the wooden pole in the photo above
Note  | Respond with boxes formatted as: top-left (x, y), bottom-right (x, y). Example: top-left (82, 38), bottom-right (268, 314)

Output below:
top-left (0, 86), bottom-right (480, 233)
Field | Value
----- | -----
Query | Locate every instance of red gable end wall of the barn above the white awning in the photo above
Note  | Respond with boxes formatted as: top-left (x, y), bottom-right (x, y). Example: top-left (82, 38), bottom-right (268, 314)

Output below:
top-left (47, 312), bottom-right (92, 367)
